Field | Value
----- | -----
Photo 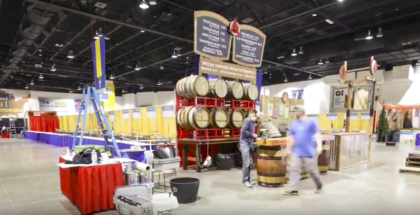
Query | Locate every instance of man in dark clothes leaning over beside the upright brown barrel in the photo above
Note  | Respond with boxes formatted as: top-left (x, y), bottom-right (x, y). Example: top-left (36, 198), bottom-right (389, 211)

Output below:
top-left (239, 112), bottom-right (263, 188)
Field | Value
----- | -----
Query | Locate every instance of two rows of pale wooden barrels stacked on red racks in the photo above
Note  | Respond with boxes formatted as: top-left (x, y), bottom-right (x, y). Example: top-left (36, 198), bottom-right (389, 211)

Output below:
top-left (175, 75), bottom-right (259, 130)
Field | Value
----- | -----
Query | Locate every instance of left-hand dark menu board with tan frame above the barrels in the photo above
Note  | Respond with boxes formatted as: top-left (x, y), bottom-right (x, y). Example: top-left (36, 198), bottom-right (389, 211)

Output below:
top-left (194, 11), bottom-right (231, 60)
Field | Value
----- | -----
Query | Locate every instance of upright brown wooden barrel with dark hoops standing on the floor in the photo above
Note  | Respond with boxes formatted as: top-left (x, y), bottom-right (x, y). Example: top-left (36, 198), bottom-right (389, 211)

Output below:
top-left (257, 145), bottom-right (287, 187)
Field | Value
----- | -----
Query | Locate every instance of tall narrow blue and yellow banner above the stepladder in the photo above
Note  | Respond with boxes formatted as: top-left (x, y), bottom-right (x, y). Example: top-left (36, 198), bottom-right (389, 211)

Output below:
top-left (91, 36), bottom-right (106, 93)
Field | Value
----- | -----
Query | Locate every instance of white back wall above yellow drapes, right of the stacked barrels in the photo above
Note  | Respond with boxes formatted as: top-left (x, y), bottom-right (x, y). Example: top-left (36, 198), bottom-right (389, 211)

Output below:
top-left (261, 65), bottom-right (420, 114)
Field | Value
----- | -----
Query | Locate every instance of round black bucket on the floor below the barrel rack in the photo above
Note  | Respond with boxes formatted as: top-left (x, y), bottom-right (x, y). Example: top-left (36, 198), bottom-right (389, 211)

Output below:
top-left (169, 178), bottom-right (200, 204)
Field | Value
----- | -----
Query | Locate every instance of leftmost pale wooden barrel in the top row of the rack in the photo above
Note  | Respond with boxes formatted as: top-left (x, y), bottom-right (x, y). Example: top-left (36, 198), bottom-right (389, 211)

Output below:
top-left (175, 75), bottom-right (210, 99)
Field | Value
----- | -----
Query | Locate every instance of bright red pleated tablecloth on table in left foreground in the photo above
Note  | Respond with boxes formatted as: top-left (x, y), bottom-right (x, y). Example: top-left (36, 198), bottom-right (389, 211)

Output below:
top-left (59, 157), bottom-right (124, 214)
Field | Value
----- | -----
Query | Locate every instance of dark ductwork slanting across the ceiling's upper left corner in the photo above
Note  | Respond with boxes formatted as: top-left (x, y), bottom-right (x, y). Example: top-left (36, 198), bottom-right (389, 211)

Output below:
top-left (0, 4), bottom-right (57, 83)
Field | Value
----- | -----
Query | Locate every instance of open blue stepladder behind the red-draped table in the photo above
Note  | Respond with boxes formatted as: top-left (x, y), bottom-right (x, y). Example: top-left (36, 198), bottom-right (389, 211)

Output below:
top-left (71, 85), bottom-right (121, 157)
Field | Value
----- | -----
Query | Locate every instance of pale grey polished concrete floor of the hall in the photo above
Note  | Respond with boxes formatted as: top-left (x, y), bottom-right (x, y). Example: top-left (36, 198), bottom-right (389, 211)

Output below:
top-left (0, 139), bottom-right (420, 215)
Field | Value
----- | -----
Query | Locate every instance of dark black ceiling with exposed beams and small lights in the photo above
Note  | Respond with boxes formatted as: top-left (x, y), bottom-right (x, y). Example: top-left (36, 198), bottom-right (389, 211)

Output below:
top-left (0, 0), bottom-right (420, 93)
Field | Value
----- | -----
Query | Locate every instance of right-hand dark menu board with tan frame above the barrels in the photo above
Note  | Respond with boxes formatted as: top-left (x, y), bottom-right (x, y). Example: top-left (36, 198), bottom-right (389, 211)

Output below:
top-left (232, 25), bottom-right (266, 67)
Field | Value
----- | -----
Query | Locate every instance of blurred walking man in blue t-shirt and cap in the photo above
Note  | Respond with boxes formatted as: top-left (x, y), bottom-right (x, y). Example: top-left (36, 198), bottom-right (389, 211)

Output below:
top-left (285, 107), bottom-right (322, 195)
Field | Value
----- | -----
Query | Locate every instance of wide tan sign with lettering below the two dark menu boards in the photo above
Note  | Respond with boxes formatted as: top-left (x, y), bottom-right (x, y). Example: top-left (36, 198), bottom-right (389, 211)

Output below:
top-left (198, 57), bottom-right (257, 82)
